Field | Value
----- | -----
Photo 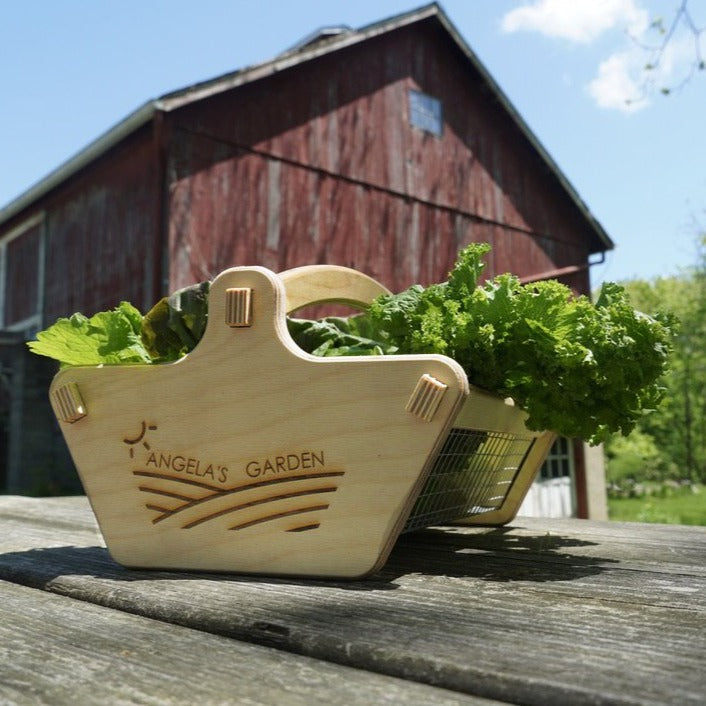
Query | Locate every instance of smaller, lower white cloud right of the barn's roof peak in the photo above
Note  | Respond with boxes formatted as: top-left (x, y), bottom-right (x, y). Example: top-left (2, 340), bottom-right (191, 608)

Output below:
top-left (586, 51), bottom-right (649, 113)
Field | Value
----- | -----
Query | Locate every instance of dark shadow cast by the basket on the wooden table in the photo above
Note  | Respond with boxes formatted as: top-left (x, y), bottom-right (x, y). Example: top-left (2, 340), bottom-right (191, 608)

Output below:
top-left (0, 527), bottom-right (615, 591)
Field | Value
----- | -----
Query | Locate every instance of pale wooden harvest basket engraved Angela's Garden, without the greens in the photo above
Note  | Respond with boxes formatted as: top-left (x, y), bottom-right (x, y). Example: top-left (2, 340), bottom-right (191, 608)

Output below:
top-left (50, 266), bottom-right (553, 578)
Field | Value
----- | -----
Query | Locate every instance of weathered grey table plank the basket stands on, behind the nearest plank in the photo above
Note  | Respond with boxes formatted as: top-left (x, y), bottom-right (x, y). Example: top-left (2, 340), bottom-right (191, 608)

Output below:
top-left (0, 498), bottom-right (706, 704)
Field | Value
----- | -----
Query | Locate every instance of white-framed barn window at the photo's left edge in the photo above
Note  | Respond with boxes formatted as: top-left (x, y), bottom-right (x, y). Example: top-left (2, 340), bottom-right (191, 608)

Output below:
top-left (0, 216), bottom-right (44, 335)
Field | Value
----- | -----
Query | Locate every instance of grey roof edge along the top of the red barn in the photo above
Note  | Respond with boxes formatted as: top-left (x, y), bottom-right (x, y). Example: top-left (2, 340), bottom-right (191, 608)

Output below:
top-left (0, 2), bottom-right (614, 250)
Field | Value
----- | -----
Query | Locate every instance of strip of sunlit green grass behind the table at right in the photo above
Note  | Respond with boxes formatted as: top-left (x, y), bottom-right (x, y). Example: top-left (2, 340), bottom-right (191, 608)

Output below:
top-left (608, 485), bottom-right (706, 525)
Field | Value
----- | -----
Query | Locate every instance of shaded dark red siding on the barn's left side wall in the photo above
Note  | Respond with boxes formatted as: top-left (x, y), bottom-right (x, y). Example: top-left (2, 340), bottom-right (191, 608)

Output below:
top-left (45, 129), bottom-right (160, 321)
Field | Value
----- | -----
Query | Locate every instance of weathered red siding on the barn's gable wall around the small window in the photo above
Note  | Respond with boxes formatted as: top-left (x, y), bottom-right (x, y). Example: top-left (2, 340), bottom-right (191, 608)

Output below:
top-left (169, 24), bottom-right (595, 290)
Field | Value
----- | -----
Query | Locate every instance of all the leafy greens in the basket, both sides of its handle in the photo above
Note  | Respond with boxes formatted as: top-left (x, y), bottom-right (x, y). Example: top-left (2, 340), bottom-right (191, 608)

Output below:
top-left (29, 244), bottom-right (676, 443)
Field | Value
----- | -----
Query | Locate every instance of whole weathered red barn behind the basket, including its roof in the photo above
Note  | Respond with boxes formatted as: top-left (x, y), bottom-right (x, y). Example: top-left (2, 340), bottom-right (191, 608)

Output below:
top-left (0, 4), bottom-right (613, 515)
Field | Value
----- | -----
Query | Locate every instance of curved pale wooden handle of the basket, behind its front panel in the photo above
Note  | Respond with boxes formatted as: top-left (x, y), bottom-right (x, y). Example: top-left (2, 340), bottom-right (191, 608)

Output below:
top-left (279, 265), bottom-right (390, 314)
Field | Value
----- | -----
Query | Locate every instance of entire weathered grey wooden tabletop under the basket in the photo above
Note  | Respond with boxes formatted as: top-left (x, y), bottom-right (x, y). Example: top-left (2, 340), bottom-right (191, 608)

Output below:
top-left (0, 496), bottom-right (706, 706)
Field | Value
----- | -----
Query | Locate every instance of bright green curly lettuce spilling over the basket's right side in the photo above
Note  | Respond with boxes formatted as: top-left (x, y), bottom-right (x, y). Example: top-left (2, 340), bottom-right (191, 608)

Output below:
top-left (288, 244), bottom-right (676, 444)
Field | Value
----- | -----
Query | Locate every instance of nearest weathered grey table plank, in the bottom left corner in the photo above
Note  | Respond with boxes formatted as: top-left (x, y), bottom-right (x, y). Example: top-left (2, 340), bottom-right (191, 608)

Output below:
top-left (0, 581), bottom-right (490, 706)
